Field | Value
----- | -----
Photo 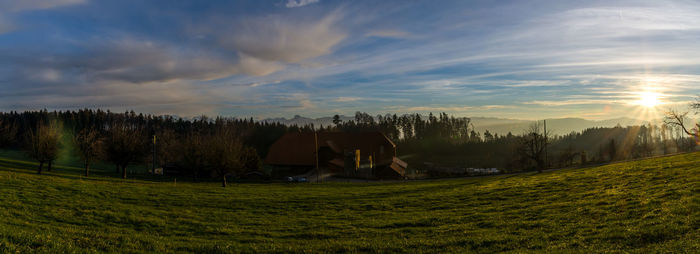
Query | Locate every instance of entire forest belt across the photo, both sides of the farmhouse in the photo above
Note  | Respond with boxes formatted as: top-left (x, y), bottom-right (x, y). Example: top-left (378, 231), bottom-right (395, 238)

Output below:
top-left (0, 106), bottom-right (697, 186)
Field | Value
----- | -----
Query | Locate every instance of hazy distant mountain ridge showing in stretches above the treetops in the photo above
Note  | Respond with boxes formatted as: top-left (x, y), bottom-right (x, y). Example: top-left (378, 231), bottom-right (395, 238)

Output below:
top-left (262, 115), bottom-right (660, 135)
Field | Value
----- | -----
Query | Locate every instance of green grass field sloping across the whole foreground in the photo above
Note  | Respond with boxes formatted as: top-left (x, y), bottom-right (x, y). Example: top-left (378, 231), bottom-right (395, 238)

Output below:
top-left (0, 153), bottom-right (700, 253)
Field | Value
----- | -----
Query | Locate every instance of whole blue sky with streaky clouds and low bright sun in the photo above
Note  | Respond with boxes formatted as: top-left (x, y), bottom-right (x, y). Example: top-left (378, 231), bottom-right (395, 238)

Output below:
top-left (0, 0), bottom-right (700, 119)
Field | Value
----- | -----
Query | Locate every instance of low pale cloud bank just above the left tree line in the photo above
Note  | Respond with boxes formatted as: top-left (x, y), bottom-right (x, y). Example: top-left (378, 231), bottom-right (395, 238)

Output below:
top-left (0, 81), bottom-right (220, 116)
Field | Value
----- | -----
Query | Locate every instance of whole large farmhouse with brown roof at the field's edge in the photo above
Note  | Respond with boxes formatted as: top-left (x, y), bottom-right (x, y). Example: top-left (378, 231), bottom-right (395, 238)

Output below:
top-left (265, 132), bottom-right (407, 179)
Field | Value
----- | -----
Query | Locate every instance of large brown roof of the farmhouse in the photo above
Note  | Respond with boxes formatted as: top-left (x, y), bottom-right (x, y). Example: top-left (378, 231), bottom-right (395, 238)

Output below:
top-left (265, 132), bottom-right (396, 166)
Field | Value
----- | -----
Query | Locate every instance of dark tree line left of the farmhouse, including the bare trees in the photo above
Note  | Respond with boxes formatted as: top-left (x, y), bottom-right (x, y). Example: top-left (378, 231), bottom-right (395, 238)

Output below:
top-left (0, 109), bottom-right (298, 185)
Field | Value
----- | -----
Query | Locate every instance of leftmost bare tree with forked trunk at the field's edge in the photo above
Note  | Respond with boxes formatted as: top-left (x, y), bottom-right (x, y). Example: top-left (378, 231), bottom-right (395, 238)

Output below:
top-left (26, 122), bottom-right (61, 174)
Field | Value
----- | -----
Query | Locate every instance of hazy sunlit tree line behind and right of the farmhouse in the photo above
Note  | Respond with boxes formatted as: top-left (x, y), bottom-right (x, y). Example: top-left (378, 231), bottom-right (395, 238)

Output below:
top-left (326, 101), bottom-right (700, 171)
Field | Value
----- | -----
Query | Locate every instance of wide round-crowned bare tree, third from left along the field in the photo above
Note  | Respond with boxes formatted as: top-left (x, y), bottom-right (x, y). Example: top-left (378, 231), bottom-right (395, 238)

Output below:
top-left (104, 123), bottom-right (147, 179)
